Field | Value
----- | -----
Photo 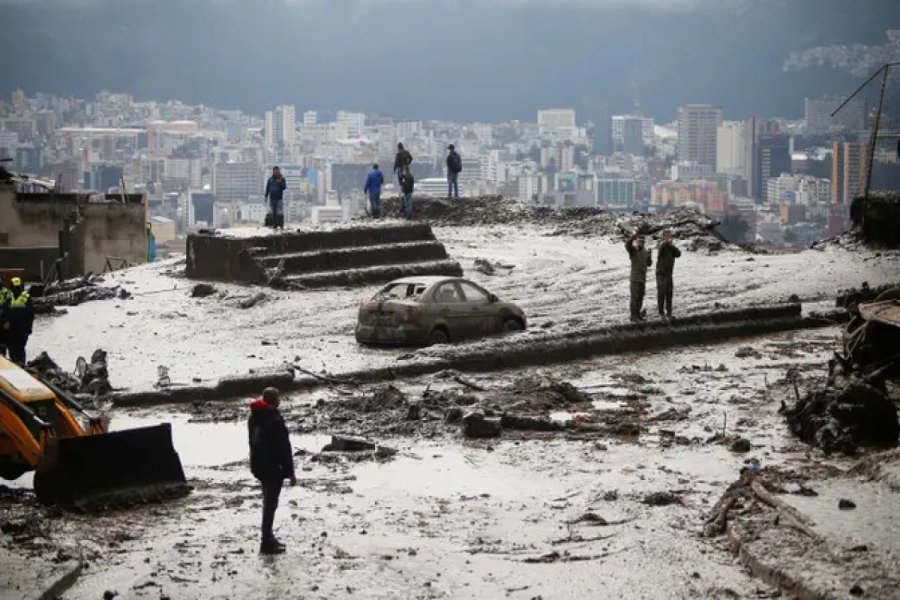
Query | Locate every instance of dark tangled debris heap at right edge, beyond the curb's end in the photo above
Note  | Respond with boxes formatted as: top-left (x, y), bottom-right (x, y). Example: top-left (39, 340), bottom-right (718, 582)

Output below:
top-left (784, 284), bottom-right (900, 454)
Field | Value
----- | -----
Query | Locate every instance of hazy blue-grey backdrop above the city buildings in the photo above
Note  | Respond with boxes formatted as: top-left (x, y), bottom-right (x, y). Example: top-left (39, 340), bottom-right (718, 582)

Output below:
top-left (0, 0), bottom-right (900, 121)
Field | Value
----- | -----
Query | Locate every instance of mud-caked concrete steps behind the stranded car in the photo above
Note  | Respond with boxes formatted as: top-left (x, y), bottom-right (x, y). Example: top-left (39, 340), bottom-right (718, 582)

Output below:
top-left (185, 223), bottom-right (462, 287)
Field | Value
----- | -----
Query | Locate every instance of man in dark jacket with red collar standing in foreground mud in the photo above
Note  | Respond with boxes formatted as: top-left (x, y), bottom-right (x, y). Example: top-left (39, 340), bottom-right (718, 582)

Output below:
top-left (247, 387), bottom-right (297, 554)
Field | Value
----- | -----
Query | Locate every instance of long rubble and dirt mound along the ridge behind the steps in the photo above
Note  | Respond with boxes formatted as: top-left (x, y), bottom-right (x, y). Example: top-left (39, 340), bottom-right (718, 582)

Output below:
top-left (384, 196), bottom-right (728, 251)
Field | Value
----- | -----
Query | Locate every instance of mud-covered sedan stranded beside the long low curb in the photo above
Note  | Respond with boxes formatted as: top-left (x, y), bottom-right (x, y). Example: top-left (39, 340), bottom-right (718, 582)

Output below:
top-left (356, 276), bottom-right (527, 345)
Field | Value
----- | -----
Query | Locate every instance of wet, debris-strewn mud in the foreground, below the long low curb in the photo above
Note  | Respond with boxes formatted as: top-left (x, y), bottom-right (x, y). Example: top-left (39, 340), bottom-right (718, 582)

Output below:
top-left (3, 330), bottom-right (848, 599)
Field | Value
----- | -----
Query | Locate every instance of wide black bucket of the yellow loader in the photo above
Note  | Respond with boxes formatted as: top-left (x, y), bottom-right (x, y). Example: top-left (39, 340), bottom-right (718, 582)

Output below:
top-left (34, 423), bottom-right (191, 510)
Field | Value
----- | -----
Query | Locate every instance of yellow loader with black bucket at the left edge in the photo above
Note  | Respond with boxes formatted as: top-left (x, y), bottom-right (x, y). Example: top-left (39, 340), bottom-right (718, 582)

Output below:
top-left (0, 357), bottom-right (191, 510)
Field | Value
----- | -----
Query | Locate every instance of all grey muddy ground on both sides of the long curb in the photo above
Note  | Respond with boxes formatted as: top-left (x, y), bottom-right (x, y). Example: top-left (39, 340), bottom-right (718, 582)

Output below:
top-left (0, 217), bottom-right (900, 599)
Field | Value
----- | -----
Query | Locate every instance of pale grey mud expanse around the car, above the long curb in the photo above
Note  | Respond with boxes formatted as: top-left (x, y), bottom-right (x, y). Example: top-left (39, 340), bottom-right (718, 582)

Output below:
top-left (29, 225), bottom-right (900, 390)
